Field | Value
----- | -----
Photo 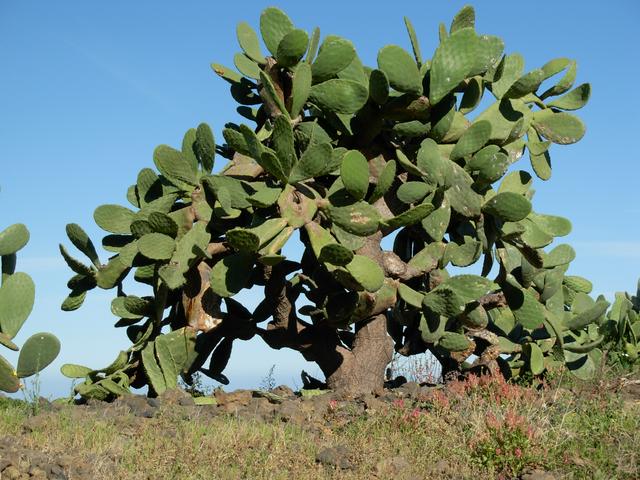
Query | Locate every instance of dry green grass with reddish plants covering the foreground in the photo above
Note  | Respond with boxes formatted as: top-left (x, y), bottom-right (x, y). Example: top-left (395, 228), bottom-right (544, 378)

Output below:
top-left (0, 378), bottom-right (640, 479)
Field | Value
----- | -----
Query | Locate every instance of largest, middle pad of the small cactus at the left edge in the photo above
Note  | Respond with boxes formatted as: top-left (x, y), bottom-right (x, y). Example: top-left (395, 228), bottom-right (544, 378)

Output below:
top-left (0, 272), bottom-right (35, 339)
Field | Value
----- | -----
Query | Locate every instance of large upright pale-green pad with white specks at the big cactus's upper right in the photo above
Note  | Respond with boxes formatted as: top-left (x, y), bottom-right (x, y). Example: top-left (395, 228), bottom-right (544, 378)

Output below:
top-left (429, 28), bottom-right (478, 105)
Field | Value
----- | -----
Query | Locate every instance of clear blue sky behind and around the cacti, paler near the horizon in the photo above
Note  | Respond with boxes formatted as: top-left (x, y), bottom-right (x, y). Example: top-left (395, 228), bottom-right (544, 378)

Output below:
top-left (0, 0), bottom-right (640, 396)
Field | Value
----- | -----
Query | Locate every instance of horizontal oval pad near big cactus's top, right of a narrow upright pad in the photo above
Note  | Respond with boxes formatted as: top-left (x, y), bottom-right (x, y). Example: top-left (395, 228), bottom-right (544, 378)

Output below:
top-left (309, 78), bottom-right (369, 115)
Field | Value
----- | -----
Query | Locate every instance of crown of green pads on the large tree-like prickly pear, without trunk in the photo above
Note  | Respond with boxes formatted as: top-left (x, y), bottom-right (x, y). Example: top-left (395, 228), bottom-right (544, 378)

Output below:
top-left (61, 7), bottom-right (607, 398)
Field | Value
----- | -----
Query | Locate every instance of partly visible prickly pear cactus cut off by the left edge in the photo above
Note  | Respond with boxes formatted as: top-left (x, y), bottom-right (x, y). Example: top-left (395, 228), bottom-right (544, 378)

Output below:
top-left (0, 223), bottom-right (60, 393)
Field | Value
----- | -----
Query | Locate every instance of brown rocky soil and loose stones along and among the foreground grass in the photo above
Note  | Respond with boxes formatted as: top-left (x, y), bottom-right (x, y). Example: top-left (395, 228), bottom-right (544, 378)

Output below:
top-left (0, 376), bottom-right (640, 480)
